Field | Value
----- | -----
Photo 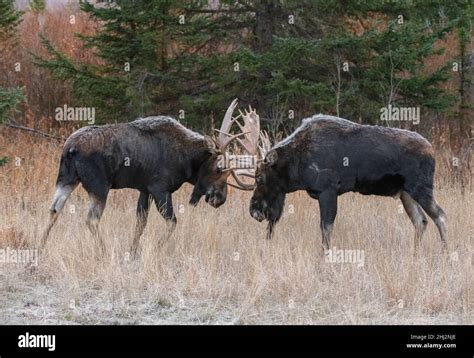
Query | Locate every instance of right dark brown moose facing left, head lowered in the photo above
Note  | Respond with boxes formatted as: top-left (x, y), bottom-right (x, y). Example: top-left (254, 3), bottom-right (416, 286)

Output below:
top-left (250, 114), bottom-right (446, 252)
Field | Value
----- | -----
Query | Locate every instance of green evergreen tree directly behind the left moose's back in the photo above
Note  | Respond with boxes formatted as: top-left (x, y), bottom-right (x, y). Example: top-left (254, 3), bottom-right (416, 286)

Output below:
top-left (35, 0), bottom-right (235, 126)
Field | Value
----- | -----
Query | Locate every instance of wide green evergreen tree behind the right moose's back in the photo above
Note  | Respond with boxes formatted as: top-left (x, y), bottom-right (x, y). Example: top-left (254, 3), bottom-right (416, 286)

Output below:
top-left (200, 0), bottom-right (462, 131)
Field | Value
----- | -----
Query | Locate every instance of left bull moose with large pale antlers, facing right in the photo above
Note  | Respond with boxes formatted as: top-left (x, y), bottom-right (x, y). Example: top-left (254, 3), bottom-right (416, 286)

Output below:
top-left (40, 99), bottom-right (260, 255)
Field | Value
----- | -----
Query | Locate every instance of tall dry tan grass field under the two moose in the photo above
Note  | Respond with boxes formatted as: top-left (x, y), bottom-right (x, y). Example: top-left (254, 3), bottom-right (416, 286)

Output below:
top-left (0, 129), bottom-right (474, 324)
